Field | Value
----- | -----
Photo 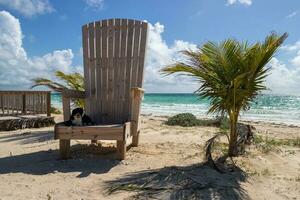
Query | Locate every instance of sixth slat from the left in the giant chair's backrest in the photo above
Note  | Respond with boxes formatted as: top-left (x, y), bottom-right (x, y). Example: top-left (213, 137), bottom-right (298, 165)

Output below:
top-left (113, 19), bottom-right (122, 123)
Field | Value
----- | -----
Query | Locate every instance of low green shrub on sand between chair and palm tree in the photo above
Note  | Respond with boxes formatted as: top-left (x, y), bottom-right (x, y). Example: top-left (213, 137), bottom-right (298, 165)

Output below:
top-left (166, 113), bottom-right (220, 127)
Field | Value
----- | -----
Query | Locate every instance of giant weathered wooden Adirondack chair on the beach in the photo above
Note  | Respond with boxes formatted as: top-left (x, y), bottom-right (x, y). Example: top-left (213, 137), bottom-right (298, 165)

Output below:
top-left (54, 19), bottom-right (147, 159)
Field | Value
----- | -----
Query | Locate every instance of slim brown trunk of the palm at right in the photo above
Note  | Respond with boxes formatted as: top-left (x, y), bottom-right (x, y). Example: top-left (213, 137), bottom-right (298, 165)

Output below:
top-left (228, 112), bottom-right (238, 157)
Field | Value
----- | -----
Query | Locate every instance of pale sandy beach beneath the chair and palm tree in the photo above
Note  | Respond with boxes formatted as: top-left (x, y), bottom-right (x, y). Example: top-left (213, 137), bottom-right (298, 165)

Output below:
top-left (0, 115), bottom-right (300, 200)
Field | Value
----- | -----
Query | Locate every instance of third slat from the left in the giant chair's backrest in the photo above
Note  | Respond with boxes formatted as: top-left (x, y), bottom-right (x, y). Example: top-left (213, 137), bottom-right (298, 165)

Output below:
top-left (94, 21), bottom-right (102, 124)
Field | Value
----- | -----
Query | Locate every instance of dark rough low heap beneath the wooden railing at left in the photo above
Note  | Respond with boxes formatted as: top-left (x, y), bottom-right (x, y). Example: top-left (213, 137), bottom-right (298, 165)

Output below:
top-left (0, 117), bottom-right (55, 131)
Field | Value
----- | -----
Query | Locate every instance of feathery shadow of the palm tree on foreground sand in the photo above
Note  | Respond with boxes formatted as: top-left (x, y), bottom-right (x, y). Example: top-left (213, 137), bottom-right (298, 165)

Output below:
top-left (106, 163), bottom-right (249, 200)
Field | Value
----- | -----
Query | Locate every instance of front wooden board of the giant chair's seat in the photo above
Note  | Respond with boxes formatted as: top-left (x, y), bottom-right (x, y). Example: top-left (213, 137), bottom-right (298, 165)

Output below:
top-left (54, 123), bottom-right (126, 140)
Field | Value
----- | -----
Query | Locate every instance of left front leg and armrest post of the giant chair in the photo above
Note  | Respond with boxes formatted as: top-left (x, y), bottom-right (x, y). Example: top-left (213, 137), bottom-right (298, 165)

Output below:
top-left (59, 96), bottom-right (71, 159)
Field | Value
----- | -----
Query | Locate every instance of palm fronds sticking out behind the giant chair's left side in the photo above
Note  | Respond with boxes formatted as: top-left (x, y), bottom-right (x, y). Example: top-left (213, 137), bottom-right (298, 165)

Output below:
top-left (32, 71), bottom-right (84, 107)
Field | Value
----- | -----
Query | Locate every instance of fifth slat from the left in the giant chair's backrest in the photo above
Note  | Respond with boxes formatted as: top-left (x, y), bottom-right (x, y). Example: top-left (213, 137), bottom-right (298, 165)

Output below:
top-left (107, 19), bottom-right (114, 123)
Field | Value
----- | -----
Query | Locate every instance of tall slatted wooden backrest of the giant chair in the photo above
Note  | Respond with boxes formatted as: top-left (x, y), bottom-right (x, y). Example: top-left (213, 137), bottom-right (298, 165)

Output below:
top-left (82, 19), bottom-right (147, 124)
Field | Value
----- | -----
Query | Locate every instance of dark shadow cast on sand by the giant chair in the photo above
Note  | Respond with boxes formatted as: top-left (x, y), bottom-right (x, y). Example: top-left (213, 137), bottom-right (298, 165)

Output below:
top-left (0, 145), bottom-right (119, 178)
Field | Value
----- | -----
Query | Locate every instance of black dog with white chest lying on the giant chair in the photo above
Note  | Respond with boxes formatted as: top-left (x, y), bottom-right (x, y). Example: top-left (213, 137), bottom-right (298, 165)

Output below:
top-left (65, 108), bottom-right (94, 126)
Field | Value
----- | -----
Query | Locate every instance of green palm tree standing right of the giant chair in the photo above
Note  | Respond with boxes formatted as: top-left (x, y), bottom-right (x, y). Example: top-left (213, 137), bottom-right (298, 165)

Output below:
top-left (162, 33), bottom-right (288, 156)
